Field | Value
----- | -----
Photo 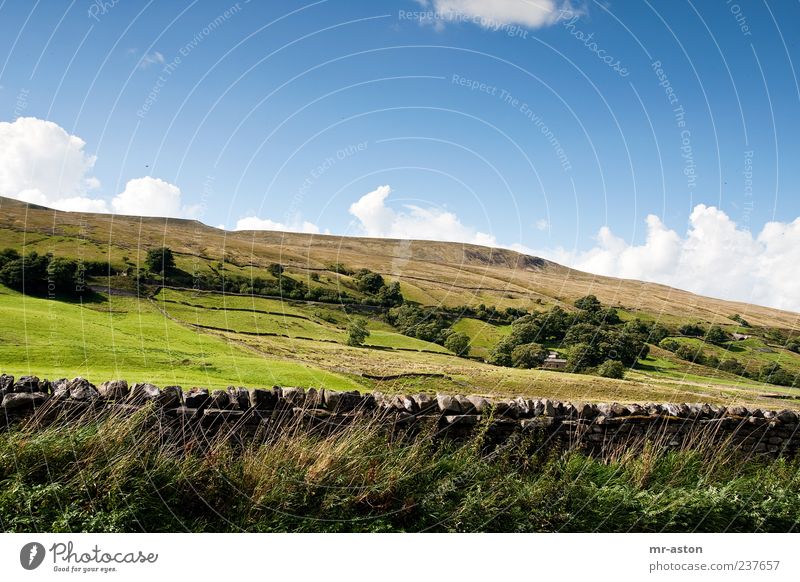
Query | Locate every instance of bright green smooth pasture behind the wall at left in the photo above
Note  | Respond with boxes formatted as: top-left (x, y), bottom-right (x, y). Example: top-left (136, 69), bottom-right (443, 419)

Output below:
top-left (0, 287), bottom-right (362, 389)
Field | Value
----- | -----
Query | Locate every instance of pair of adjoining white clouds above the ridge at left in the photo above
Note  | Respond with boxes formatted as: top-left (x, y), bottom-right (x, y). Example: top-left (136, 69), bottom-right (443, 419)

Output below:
top-left (0, 117), bottom-right (199, 218)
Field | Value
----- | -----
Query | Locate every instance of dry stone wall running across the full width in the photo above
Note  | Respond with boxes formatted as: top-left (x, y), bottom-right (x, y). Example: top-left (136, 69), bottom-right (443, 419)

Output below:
top-left (0, 374), bottom-right (800, 456)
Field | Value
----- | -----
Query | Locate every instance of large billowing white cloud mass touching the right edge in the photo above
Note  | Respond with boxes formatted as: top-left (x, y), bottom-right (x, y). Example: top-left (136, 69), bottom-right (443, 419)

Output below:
top-left (540, 204), bottom-right (800, 311)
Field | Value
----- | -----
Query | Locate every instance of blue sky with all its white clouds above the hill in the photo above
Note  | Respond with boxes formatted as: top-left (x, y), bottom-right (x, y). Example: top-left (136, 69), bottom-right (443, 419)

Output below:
top-left (0, 0), bottom-right (800, 311)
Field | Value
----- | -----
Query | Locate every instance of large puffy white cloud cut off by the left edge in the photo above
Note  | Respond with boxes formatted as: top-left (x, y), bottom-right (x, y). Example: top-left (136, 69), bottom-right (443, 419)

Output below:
top-left (0, 117), bottom-right (99, 206)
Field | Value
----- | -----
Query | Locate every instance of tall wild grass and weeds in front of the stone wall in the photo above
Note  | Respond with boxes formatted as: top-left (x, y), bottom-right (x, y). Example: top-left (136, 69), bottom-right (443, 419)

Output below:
top-left (0, 408), bottom-right (800, 532)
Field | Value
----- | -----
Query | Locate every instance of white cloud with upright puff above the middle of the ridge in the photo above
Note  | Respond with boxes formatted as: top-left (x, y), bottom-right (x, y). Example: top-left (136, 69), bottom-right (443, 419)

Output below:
top-left (350, 186), bottom-right (497, 246)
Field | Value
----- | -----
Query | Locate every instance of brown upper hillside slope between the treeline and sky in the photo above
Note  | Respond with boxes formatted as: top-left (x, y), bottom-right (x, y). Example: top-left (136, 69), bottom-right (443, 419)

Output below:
top-left (0, 197), bottom-right (800, 329)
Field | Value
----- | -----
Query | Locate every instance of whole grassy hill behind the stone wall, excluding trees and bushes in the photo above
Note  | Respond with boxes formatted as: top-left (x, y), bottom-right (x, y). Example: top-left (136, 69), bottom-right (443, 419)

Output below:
top-left (0, 198), bottom-right (800, 407)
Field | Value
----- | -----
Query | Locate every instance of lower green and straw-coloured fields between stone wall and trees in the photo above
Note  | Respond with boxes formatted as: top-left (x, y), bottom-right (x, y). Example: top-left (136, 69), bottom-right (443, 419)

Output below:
top-left (0, 288), bottom-right (796, 407)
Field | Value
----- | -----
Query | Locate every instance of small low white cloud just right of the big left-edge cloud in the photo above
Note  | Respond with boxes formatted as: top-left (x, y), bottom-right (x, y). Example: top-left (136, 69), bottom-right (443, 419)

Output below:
top-left (111, 176), bottom-right (199, 218)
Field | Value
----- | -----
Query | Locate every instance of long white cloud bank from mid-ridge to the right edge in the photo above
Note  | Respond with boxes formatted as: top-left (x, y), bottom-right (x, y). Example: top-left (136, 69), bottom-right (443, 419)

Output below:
top-left (350, 185), bottom-right (800, 311)
